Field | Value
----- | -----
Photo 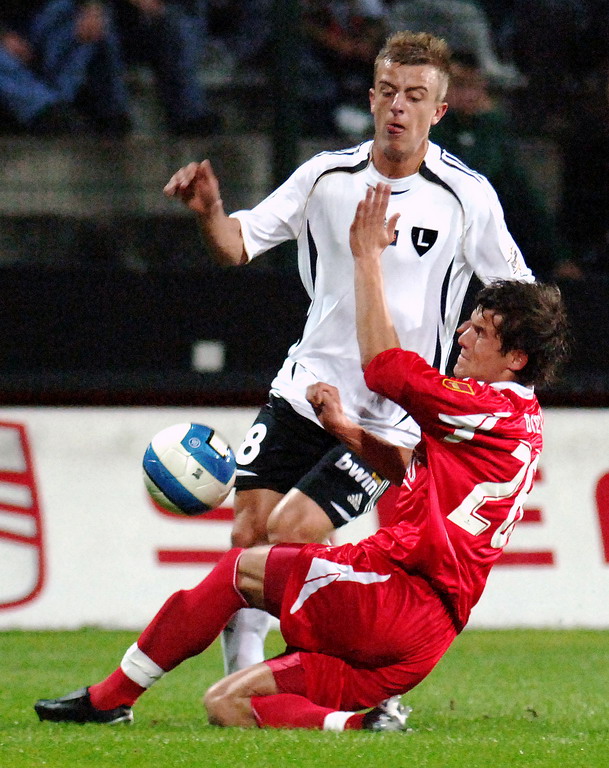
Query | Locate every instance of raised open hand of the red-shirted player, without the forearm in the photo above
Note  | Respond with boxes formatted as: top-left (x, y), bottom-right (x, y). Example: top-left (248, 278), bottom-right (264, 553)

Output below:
top-left (349, 182), bottom-right (400, 259)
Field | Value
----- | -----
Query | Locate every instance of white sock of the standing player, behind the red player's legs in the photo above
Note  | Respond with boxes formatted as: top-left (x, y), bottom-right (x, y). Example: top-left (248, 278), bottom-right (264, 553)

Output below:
top-left (222, 608), bottom-right (271, 675)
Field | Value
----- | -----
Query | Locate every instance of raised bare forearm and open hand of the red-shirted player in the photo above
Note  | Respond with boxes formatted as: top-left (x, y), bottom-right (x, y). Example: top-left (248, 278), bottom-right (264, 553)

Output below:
top-left (349, 183), bottom-right (400, 369)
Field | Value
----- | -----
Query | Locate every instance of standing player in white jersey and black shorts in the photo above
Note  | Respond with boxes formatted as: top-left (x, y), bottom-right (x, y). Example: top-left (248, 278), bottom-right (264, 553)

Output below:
top-left (165, 32), bottom-right (533, 671)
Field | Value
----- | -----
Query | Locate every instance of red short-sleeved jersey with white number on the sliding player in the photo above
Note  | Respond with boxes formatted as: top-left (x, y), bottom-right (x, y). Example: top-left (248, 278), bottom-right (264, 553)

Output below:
top-left (360, 349), bottom-right (543, 630)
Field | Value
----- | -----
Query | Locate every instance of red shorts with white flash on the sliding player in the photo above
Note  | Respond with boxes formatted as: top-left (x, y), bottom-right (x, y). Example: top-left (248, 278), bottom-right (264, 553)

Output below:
top-left (265, 544), bottom-right (457, 710)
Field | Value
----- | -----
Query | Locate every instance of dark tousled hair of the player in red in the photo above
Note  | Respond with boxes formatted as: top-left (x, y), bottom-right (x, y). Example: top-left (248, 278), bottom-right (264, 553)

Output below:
top-left (476, 280), bottom-right (569, 386)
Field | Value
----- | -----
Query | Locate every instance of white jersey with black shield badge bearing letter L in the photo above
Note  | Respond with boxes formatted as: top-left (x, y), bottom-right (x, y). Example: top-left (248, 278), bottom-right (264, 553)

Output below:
top-left (232, 141), bottom-right (533, 448)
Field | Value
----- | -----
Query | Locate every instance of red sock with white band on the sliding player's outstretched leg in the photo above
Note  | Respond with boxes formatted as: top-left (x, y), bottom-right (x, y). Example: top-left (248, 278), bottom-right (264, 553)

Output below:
top-left (89, 549), bottom-right (247, 709)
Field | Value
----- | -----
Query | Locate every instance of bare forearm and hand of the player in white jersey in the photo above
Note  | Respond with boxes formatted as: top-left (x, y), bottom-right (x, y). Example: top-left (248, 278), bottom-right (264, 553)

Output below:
top-left (163, 160), bottom-right (248, 266)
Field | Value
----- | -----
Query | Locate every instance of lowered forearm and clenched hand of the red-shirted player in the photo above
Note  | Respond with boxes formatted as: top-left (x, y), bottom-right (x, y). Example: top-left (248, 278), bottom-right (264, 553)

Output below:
top-left (307, 382), bottom-right (412, 485)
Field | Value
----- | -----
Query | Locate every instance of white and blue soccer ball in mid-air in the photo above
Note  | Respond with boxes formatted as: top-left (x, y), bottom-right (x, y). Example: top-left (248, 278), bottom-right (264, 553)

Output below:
top-left (143, 424), bottom-right (236, 516)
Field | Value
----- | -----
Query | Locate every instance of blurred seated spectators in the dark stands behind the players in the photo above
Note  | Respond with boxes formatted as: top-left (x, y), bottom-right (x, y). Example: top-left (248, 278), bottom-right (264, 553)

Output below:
top-left (0, 0), bottom-right (609, 279)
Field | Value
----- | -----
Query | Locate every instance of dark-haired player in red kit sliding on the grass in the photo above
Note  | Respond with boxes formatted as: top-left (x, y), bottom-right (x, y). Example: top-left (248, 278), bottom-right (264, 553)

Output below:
top-left (35, 184), bottom-right (566, 731)
